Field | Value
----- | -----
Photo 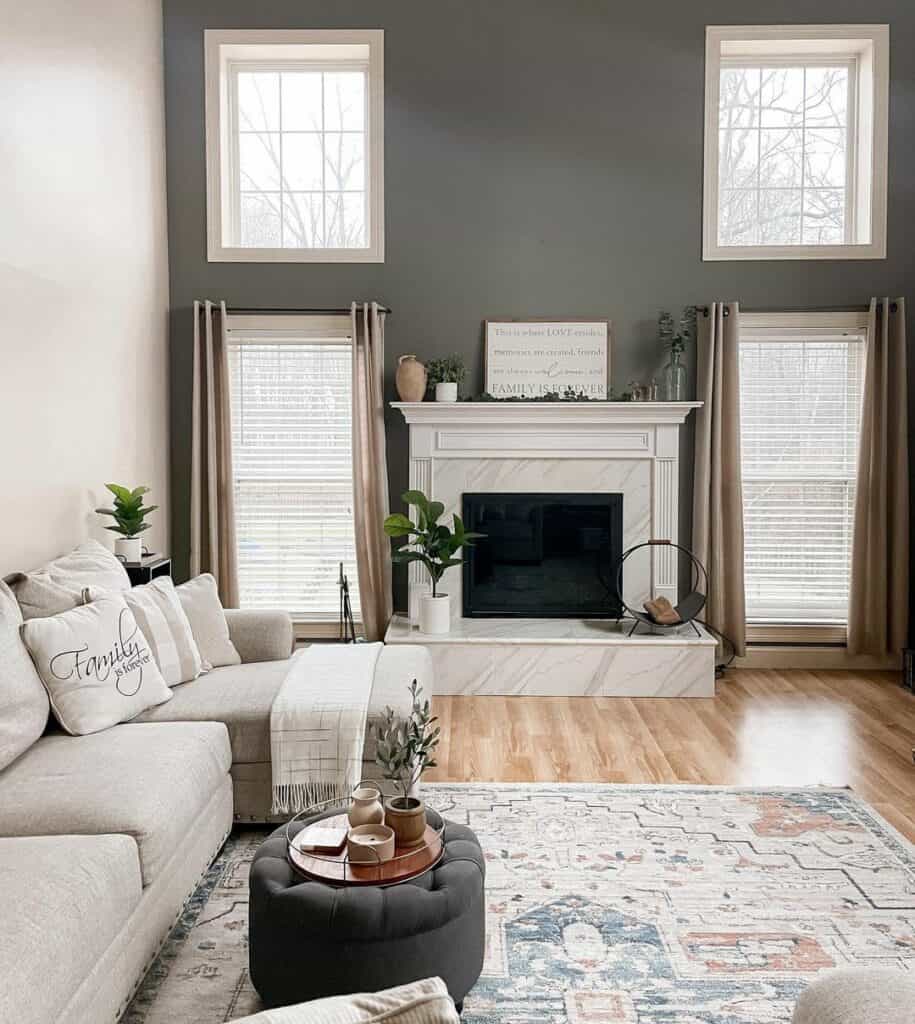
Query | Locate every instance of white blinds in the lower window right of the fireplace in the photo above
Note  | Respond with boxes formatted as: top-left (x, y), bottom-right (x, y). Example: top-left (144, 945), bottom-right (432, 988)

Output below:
top-left (740, 314), bottom-right (866, 625)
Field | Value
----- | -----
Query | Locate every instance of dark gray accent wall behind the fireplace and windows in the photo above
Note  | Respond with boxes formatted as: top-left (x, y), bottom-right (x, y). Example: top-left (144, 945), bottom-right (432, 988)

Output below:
top-left (165, 0), bottom-right (915, 604)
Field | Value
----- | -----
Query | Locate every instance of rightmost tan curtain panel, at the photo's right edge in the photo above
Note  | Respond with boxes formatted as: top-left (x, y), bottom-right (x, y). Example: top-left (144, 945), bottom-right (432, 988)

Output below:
top-left (848, 299), bottom-right (909, 655)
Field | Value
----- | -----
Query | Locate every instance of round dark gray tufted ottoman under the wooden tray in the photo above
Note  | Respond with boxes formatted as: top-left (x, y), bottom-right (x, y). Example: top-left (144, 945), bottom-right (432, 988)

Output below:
top-left (243, 812), bottom-right (485, 1007)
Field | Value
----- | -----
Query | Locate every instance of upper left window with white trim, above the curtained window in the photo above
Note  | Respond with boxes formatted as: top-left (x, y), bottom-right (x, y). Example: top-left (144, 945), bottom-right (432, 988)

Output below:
top-left (206, 30), bottom-right (384, 262)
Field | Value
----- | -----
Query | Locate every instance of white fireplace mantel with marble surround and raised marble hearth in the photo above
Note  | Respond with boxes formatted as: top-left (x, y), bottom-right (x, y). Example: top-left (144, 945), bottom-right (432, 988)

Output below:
top-left (385, 402), bottom-right (714, 696)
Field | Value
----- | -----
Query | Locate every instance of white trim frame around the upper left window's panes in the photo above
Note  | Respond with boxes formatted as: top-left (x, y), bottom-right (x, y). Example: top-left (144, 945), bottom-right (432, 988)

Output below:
top-left (204, 29), bottom-right (385, 263)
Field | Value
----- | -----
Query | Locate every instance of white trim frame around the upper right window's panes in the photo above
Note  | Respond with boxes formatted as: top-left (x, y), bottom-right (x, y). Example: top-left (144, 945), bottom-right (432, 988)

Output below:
top-left (702, 25), bottom-right (889, 260)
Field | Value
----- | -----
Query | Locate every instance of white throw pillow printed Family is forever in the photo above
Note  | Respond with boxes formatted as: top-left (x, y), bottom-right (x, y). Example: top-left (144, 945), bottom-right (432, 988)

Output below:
top-left (23, 594), bottom-right (172, 736)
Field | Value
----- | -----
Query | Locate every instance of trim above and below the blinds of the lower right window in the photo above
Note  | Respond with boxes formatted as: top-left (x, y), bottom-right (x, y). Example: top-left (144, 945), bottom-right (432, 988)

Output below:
top-left (740, 311), bottom-right (870, 646)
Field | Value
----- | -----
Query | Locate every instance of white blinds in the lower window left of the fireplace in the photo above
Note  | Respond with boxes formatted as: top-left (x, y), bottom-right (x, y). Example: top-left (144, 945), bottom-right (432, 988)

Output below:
top-left (228, 315), bottom-right (359, 623)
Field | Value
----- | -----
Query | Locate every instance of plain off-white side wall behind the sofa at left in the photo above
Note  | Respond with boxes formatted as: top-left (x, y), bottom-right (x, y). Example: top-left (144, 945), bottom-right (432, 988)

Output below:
top-left (0, 0), bottom-right (169, 574)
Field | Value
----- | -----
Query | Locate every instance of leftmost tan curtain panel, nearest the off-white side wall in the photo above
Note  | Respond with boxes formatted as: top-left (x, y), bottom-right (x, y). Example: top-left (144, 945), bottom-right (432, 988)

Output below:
top-left (190, 302), bottom-right (238, 608)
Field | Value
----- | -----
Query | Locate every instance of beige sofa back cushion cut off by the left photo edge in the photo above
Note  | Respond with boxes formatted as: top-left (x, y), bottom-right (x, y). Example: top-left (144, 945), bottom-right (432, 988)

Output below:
top-left (0, 582), bottom-right (49, 771)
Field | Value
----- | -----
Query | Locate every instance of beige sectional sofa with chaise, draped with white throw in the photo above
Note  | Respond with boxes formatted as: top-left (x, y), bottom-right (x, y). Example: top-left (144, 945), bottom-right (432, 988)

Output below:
top-left (0, 569), bottom-right (431, 1024)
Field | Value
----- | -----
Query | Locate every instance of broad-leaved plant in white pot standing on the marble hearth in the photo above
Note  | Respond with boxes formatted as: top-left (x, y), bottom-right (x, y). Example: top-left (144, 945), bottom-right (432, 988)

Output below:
top-left (385, 490), bottom-right (485, 634)
